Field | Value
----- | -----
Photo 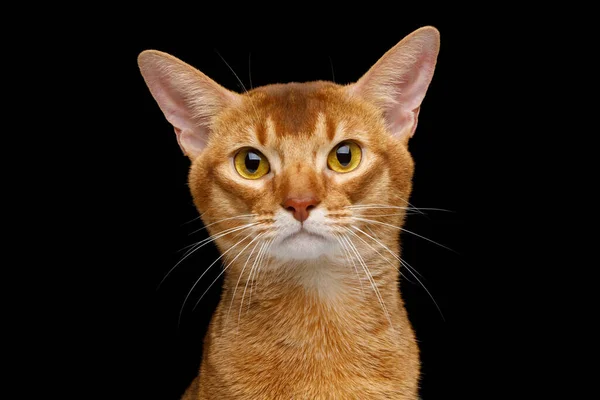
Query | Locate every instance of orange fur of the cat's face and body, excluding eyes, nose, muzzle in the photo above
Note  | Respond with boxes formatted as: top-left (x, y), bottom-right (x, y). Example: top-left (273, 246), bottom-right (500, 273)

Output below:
top-left (140, 28), bottom-right (437, 400)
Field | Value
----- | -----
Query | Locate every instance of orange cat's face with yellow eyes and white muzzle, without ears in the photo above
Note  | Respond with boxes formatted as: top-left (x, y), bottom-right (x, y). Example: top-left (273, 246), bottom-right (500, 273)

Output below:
top-left (190, 82), bottom-right (413, 260)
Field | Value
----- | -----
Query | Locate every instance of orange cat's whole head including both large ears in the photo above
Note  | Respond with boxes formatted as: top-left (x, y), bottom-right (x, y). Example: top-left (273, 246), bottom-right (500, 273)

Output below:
top-left (138, 27), bottom-right (439, 266)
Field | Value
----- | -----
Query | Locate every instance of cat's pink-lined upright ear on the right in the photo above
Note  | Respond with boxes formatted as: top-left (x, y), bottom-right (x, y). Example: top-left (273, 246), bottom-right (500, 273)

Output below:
top-left (349, 26), bottom-right (440, 140)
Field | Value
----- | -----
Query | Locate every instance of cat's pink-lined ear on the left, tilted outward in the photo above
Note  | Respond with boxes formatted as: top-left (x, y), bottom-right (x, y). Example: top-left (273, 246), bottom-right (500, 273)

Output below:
top-left (138, 50), bottom-right (241, 159)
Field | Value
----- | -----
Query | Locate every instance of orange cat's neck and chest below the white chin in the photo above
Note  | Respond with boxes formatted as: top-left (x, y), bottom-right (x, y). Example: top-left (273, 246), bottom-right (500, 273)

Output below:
top-left (200, 260), bottom-right (419, 399)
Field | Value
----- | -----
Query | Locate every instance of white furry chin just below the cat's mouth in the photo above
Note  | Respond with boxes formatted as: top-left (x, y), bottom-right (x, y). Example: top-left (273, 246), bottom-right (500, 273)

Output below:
top-left (270, 232), bottom-right (335, 261)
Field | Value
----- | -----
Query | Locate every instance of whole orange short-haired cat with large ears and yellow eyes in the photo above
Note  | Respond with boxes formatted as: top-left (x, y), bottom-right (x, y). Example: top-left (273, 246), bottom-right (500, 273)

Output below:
top-left (138, 26), bottom-right (439, 400)
